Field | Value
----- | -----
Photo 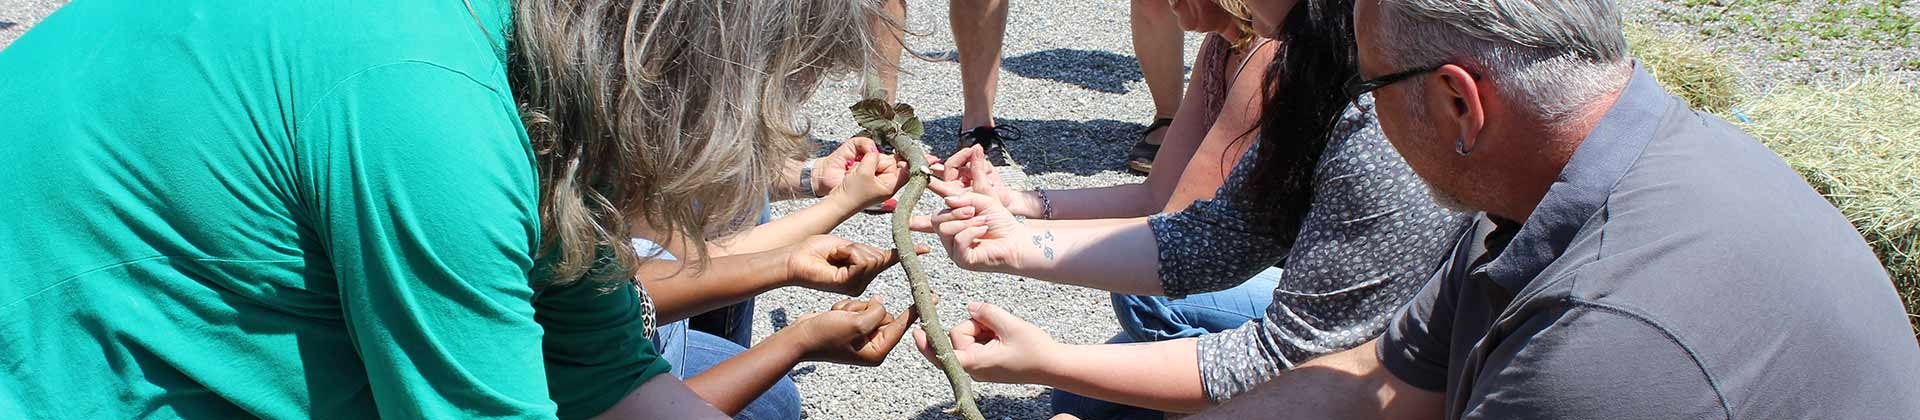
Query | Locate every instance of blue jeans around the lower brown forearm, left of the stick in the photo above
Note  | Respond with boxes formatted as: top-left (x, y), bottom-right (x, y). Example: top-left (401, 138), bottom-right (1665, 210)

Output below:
top-left (655, 320), bottom-right (801, 420)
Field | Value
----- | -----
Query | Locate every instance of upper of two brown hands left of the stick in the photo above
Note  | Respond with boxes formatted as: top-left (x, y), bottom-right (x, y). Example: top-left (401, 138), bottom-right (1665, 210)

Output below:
top-left (783, 234), bottom-right (929, 295)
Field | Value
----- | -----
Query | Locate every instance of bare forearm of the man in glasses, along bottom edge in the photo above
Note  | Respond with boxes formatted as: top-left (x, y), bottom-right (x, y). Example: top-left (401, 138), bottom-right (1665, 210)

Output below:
top-left (1194, 341), bottom-right (1444, 418)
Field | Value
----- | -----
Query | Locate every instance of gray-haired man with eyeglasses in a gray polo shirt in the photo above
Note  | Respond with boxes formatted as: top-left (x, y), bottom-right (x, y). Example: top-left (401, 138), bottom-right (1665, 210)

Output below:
top-left (1208, 0), bottom-right (1920, 418)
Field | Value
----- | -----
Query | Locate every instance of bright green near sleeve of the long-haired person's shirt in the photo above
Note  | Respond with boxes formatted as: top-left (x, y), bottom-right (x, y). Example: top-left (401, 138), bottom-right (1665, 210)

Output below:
top-left (296, 61), bottom-right (555, 418)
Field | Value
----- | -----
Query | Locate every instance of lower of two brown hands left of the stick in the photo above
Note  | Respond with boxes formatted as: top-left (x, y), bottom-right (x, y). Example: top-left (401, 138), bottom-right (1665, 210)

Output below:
top-left (781, 295), bottom-right (916, 366)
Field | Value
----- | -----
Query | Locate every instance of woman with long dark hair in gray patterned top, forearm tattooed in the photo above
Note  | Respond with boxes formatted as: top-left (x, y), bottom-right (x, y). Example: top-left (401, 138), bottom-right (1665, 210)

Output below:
top-left (916, 0), bottom-right (1465, 418)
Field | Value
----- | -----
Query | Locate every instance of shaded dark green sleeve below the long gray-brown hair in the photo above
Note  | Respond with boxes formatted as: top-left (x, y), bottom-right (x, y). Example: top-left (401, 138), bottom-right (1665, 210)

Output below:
top-left (534, 274), bottom-right (672, 418)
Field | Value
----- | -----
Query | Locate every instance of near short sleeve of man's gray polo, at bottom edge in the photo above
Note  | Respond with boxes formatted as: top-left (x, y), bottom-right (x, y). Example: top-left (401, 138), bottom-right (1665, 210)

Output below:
top-left (1459, 303), bottom-right (1732, 420)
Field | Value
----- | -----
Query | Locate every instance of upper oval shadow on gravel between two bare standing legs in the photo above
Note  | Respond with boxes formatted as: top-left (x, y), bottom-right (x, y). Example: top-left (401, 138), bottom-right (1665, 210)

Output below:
top-left (1000, 48), bottom-right (1142, 94)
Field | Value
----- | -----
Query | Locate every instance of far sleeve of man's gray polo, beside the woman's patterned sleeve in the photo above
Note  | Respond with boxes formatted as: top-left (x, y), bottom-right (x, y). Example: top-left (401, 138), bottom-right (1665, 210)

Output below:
top-left (1377, 217), bottom-right (1494, 393)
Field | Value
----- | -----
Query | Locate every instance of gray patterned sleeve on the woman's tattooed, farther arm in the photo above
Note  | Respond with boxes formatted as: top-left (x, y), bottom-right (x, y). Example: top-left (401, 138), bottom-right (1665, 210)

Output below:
top-left (1146, 144), bottom-right (1290, 299)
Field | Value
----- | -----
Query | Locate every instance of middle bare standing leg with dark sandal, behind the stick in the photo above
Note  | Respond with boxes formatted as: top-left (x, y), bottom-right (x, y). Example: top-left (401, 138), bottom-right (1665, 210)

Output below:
top-left (947, 0), bottom-right (1018, 165)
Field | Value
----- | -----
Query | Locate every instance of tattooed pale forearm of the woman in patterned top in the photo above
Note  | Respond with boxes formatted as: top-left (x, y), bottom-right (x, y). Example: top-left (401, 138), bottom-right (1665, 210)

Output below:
top-left (1008, 219), bottom-right (1165, 295)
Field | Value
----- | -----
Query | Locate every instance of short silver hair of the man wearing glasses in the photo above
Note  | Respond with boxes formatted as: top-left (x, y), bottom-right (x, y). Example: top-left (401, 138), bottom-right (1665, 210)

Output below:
top-left (1377, 0), bottom-right (1628, 121)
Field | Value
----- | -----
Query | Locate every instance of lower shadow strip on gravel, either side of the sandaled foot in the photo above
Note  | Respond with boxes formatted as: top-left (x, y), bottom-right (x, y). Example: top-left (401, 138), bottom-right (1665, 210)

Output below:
top-left (922, 115), bottom-right (1146, 176)
